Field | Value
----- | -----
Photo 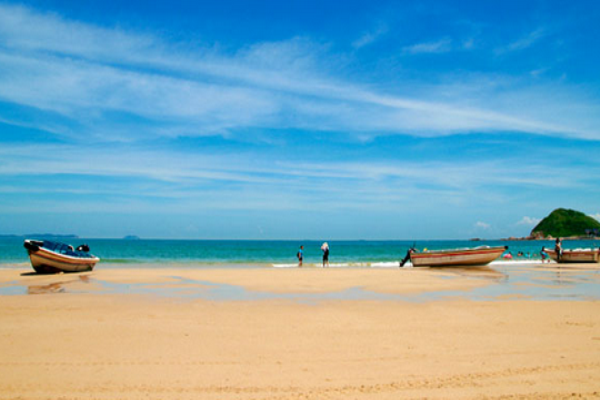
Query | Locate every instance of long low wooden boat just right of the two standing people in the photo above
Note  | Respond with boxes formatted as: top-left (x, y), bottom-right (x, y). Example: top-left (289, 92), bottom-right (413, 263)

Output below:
top-left (410, 246), bottom-right (508, 267)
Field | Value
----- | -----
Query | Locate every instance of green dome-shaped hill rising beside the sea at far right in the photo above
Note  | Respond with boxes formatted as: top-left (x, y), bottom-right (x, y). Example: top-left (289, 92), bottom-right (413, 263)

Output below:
top-left (531, 208), bottom-right (600, 238)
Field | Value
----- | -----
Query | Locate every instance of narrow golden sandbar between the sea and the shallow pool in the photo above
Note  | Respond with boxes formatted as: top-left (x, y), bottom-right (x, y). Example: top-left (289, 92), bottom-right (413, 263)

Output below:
top-left (0, 267), bottom-right (499, 300)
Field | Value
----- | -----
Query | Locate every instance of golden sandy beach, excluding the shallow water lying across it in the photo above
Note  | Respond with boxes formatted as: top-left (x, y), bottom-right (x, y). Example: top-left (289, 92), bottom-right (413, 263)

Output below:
top-left (0, 269), bottom-right (600, 399)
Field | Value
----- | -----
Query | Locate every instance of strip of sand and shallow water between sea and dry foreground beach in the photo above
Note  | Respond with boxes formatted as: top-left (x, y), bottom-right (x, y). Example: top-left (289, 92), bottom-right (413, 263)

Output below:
top-left (0, 261), bottom-right (600, 302)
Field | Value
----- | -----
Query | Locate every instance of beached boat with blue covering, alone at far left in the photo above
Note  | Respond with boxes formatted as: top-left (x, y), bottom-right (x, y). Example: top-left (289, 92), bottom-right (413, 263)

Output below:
top-left (23, 239), bottom-right (100, 273)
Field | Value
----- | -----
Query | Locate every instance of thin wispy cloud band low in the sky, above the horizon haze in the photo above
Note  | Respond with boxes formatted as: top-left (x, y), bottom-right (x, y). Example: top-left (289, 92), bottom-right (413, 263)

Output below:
top-left (0, 143), bottom-right (588, 208)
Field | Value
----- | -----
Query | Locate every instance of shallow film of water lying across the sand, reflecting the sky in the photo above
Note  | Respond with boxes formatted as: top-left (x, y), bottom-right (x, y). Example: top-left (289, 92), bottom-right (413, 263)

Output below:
top-left (0, 262), bottom-right (600, 303)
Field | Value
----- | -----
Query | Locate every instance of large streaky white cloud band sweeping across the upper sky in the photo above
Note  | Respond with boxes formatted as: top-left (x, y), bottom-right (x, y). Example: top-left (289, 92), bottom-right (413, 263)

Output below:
top-left (0, 5), bottom-right (600, 140)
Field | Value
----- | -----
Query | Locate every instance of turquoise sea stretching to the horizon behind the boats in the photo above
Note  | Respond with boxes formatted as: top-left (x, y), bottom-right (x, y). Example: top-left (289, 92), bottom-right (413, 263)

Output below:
top-left (0, 238), bottom-right (600, 268)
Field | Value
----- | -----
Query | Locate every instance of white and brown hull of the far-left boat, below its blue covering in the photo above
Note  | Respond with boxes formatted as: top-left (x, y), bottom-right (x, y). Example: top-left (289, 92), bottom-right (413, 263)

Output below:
top-left (25, 241), bottom-right (100, 274)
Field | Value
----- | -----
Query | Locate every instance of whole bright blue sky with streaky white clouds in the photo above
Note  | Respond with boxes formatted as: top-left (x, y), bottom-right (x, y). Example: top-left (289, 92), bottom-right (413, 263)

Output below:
top-left (0, 0), bottom-right (600, 240)
